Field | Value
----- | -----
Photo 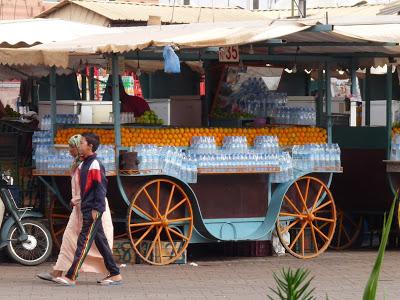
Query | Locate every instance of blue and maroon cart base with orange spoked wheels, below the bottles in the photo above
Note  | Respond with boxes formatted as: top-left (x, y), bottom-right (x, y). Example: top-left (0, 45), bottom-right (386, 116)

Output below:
top-left (36, 145), bottom-right (336, 265)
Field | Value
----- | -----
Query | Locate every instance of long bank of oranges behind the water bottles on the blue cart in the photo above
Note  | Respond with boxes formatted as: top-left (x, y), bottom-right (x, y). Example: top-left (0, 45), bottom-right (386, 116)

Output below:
top-left (55, 127), bottom-right (327, 147)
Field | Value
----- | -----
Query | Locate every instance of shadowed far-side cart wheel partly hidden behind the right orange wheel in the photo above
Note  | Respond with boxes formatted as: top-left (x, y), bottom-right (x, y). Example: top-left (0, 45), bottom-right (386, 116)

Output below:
top-left (329, 209), bottom-right (363, 250)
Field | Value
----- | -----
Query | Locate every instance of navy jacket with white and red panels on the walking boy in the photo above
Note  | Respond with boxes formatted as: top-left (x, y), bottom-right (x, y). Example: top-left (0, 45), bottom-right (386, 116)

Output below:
top-left (79, 154), bottom-right (107, 214)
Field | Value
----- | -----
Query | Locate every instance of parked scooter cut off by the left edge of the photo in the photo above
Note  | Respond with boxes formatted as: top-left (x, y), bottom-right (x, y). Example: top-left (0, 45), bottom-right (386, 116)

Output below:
top-left (0, 173), bottom-right (53, 266)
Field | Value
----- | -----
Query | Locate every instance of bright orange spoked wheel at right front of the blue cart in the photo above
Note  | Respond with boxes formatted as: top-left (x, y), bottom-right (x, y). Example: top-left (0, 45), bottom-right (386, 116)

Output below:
top-left (276, 176), bottom-right (336, 258)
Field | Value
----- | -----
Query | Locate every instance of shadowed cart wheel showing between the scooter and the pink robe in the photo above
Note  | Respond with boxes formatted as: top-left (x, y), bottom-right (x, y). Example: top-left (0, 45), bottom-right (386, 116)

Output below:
top-left (49, 198), bottom-right (71, 249)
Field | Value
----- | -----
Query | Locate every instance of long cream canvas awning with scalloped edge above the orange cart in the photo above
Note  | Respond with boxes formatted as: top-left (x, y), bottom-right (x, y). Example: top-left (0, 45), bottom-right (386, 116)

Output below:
top-left (0, 21), bottom-right (309, 68)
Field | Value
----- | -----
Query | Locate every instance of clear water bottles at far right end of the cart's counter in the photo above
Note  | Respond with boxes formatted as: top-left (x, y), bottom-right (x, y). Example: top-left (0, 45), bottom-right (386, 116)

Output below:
top-left (292, 144), bottom-right (341, 171)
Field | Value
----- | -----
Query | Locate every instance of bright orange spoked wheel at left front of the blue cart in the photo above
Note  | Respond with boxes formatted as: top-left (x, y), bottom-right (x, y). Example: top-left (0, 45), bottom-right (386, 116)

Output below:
top-left (127, 179), bottom-right (193, 265)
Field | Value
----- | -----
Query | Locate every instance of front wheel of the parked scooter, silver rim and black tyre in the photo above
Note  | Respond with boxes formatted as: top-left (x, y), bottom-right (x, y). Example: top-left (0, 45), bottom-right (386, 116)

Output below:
top-left (7, 219), bottom-right (53, 266)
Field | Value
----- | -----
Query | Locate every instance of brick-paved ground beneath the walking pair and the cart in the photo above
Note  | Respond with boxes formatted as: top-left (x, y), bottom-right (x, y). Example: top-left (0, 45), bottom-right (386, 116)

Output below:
top-left (0, 251), bottom-right (400, 300)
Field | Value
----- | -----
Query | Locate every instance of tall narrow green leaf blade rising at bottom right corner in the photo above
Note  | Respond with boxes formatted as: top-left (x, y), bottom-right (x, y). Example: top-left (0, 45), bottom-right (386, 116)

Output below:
top-left (363, 191), bottom-right (398, 300)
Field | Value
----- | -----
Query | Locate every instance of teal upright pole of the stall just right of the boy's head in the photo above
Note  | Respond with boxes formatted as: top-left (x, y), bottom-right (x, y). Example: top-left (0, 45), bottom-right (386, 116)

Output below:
top-left (112, 53), bottom-right (121, 149)
